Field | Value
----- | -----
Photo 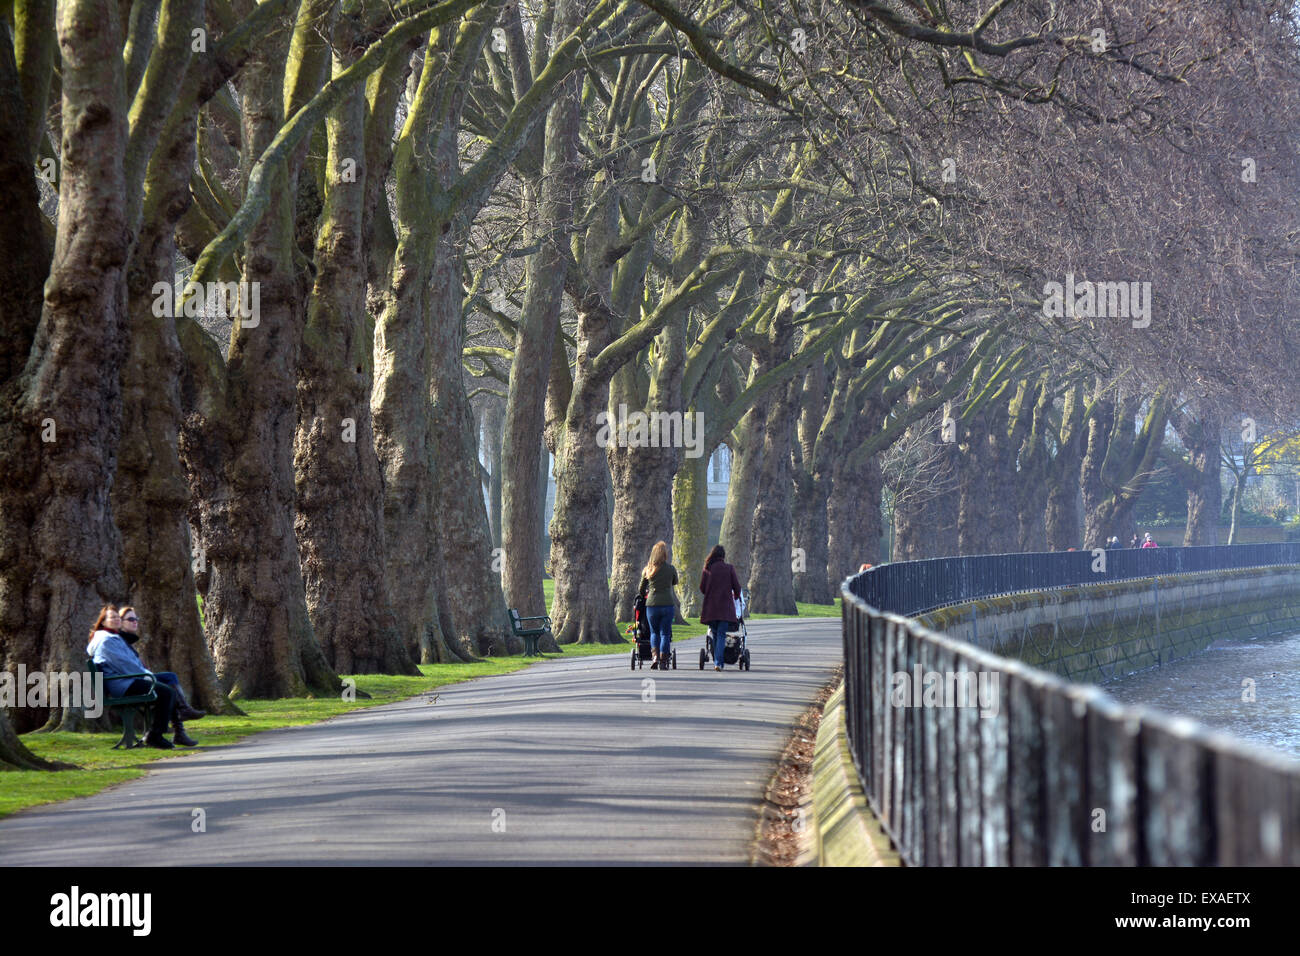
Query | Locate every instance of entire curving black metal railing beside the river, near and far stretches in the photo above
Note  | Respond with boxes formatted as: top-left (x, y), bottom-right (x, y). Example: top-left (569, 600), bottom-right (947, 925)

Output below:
top-left (842, 544), bottom-right (1300, 866)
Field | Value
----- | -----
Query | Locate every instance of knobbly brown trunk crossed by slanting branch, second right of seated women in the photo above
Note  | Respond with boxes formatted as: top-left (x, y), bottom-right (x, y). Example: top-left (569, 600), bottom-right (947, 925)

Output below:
top-left (182, 26), bottom-right (342, 697)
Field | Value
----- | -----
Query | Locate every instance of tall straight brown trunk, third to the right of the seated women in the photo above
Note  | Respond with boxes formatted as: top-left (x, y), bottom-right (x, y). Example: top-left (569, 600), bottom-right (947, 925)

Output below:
top-left (294, 60), bottom-right (420, 675)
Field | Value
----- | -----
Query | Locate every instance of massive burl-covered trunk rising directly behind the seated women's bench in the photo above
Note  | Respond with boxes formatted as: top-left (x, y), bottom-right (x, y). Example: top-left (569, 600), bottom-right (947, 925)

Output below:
top-left (0, 0), bottom-right (133, 732)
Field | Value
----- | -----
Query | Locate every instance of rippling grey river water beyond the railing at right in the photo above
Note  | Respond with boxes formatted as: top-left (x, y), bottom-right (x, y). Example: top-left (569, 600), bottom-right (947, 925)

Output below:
top-left (1101, 635), bottom-right (1300, 757)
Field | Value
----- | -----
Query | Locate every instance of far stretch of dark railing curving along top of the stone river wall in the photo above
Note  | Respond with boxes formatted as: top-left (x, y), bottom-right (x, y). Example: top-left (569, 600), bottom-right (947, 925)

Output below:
top-left (846, 542), bottom-right (1300, 615)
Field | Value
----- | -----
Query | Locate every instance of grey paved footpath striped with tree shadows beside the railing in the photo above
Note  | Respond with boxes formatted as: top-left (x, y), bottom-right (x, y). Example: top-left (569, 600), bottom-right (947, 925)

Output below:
top-left (0, 618), bottom-right (841, 866)
